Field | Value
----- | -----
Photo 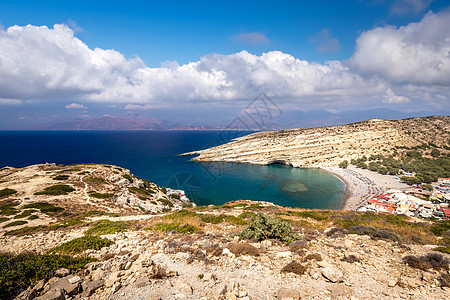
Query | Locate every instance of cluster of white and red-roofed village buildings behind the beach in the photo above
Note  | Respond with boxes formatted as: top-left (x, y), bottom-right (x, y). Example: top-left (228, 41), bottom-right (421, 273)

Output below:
top-left (358, 178), bottom-right (450, 220)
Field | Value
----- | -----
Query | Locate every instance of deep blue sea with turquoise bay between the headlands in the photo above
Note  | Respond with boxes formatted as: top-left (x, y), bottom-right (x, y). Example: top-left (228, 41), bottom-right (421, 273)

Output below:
top-left (0, 131), bottom-right (345, 209)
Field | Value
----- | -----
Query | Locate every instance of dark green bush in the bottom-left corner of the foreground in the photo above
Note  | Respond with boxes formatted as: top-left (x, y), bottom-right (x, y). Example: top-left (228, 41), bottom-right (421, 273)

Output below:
top-left (0, 253), bottom-right (95, 299)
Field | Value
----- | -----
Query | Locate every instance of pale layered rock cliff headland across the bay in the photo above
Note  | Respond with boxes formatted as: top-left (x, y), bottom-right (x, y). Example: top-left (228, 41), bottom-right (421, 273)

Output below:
top-left (187, 116), bottom-right (450, 167)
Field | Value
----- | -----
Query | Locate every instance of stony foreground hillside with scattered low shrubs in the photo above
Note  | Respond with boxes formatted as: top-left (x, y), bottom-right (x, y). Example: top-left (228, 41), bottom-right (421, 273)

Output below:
top-left (0, 201), bottom-right (450, 300)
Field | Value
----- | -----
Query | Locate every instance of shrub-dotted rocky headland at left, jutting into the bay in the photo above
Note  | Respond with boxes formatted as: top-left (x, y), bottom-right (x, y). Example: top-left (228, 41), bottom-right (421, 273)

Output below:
top-left (0, 164), bottom-right (195, 233)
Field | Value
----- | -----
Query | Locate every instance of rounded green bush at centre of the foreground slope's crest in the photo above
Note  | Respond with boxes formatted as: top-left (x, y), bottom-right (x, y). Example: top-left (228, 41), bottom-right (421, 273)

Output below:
top-left (239, 213), bottom-right (298, 242)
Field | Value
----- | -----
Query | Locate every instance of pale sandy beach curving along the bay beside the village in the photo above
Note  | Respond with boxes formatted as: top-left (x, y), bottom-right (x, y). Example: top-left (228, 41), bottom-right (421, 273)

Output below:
top-left (322, 166), bottom-right (408, 210)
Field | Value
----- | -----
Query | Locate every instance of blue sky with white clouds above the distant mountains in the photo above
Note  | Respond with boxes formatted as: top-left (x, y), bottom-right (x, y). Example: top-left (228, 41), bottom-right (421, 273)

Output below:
top-left (0, 0), bottom-right (450, 129)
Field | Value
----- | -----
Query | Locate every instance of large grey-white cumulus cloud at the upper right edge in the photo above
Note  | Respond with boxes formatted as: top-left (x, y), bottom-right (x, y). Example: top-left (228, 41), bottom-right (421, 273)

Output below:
top-left (349, 10), bottom-right (450, 86)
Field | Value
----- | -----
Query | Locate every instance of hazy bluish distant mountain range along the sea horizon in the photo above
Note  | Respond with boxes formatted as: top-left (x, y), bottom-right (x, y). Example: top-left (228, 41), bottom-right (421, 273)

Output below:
top-left (9, 108), bottom-right (449, 131)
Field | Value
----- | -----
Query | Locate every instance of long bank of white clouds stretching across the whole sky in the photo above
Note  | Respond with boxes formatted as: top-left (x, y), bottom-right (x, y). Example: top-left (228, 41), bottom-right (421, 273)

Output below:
top-left (0, 13), bottom-right (450, 110)
